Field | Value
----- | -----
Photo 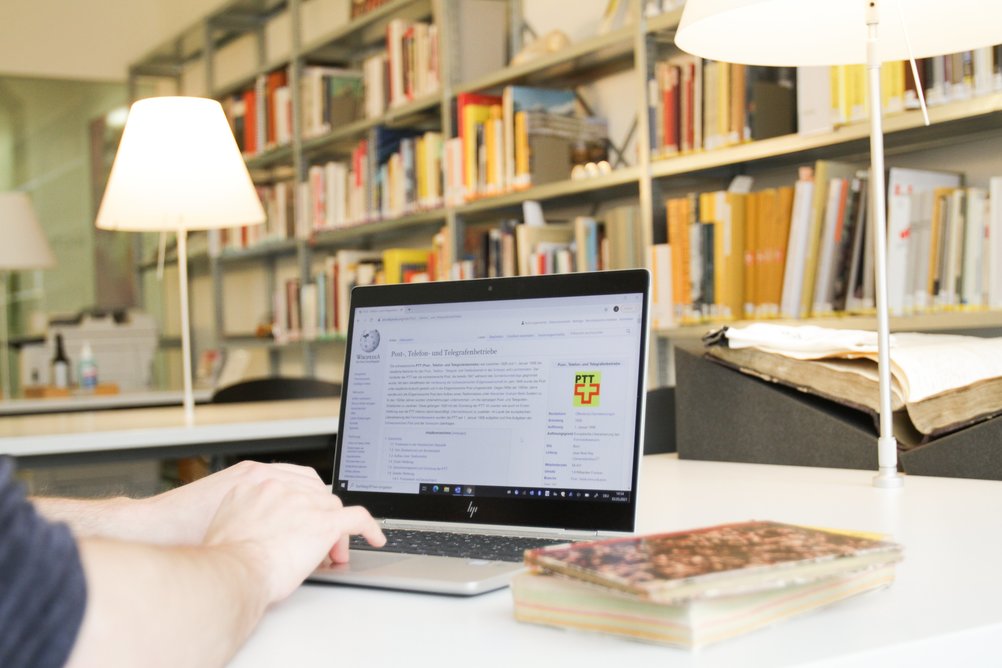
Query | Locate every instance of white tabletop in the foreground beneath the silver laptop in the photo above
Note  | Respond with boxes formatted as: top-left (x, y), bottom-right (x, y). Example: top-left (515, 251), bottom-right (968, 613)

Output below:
top-left (232, 454), bottom-right (1002, 668)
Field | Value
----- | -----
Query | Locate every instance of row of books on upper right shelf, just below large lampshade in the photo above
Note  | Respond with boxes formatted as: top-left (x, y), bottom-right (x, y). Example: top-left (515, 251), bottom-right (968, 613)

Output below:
top-left (648, 46), bottom-right (1002, 158)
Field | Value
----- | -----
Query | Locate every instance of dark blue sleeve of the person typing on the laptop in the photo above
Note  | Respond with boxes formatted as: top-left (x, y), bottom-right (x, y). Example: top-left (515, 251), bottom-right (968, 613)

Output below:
top-left (0, 457), bottom-right (86, 668)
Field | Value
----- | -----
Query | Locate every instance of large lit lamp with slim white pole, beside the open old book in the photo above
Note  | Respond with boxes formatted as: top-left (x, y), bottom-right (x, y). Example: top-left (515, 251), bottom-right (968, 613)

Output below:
top-left (675, 0), bottom-right (1002, 488)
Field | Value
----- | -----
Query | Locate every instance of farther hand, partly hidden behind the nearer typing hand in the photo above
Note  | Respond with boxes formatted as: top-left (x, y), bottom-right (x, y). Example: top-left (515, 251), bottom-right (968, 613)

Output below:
top-left (136, 461), bottom-right (330, 545)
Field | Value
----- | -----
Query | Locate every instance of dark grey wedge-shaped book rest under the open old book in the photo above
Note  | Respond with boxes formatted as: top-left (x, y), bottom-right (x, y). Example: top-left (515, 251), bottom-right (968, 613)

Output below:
top-left (675, 345), bottom-right (1002, 480)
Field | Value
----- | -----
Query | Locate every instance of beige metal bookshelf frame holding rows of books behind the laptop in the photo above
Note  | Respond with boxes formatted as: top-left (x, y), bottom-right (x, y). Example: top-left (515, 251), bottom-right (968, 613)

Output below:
top-left (130, 0), bottom-right (1002, 383)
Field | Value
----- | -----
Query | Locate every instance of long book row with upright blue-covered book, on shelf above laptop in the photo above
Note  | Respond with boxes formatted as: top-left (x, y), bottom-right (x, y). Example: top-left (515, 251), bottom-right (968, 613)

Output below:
top-left (226, 88), bottom-right (605, 247)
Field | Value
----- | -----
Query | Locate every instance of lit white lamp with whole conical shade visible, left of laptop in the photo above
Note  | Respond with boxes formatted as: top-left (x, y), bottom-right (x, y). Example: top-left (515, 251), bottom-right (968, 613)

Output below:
top-left (97, 97), bottom-right (265, 425)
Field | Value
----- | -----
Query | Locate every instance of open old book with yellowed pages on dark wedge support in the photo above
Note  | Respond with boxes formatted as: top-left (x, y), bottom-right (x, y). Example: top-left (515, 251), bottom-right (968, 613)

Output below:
top-left (706, 322), bottom-right (1002, 445)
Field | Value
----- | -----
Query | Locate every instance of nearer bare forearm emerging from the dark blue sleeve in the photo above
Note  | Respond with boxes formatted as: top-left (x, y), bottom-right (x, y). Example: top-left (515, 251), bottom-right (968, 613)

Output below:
top-left (69, 539), bottom-right (268, 666)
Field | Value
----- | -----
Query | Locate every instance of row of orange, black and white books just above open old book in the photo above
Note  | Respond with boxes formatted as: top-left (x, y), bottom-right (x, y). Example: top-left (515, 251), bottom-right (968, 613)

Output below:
top-left (652, 160), bottom-right (1002, 323)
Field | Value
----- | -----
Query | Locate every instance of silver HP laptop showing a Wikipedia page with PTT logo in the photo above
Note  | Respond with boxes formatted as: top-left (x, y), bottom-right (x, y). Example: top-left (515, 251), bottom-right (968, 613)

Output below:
top-left (311, 269), bottom-right (649, 595)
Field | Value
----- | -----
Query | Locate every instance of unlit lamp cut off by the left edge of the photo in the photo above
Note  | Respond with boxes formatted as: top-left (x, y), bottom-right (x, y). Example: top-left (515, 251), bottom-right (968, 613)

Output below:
top-left (0, 192), bottom-right (56, 399)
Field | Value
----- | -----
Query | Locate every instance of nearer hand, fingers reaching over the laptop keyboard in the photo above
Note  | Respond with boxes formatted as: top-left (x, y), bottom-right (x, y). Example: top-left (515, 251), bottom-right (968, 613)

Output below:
top-left (204, 477), bottom-right (386, 604)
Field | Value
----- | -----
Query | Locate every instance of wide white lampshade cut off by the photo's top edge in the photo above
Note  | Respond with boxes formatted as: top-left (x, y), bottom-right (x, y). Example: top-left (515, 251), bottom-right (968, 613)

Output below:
top-left (675, 0), bottom-right (1002, 66)
